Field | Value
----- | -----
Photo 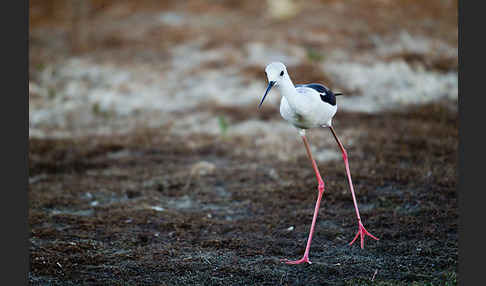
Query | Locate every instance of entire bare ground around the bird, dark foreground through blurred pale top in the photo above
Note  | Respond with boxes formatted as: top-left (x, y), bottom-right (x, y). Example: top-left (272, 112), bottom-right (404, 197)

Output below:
top-left (29, 0), bottom-right (458, 285)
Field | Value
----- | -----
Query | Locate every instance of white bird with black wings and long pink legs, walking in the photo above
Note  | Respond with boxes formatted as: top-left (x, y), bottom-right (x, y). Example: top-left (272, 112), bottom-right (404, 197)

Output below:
top-left (258, 62), bottom-right (379, 264)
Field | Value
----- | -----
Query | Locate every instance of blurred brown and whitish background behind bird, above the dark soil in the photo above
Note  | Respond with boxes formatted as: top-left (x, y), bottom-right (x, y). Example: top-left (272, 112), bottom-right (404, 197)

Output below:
top-left (29, 0), bottom-right (458, 143)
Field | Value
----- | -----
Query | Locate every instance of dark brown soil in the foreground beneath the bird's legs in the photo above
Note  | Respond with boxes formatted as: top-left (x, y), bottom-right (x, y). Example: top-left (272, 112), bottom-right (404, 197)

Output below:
top-left (29, 104), bottom-right (458, 285)
